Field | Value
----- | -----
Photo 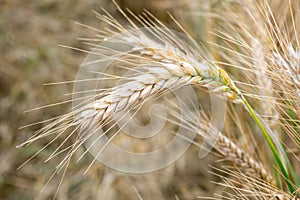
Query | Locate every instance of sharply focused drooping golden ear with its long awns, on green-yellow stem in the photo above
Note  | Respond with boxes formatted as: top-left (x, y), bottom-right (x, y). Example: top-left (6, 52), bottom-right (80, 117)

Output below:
top-left (20, 8), bottom-right (244, 178)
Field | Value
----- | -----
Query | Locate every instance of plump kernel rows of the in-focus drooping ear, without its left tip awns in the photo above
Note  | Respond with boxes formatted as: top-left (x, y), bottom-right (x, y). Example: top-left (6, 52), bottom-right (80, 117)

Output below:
top-left (75, 10), bottom-right (245, 130)
